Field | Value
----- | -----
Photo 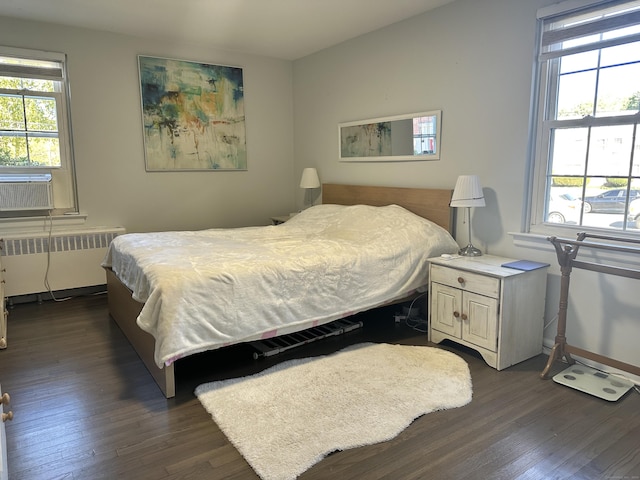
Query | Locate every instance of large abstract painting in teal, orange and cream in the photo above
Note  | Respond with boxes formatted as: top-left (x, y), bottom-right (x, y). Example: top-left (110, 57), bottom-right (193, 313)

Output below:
top-left (138, 55), bottom-right (247, 172)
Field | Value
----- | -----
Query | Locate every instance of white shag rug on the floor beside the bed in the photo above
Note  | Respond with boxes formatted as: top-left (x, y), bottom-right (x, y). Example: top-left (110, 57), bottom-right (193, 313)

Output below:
top-left (195, 343), bottom-right (472, 480)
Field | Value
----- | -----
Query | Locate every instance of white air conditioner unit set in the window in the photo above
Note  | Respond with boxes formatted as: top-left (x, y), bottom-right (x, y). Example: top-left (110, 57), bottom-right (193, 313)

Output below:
top-left (0, 175), bottom-right (53, 212)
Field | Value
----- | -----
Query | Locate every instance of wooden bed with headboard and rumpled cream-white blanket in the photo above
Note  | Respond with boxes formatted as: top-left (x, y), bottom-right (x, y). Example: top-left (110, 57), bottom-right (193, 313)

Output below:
top-left (103, 184), bottom-right (458, 398)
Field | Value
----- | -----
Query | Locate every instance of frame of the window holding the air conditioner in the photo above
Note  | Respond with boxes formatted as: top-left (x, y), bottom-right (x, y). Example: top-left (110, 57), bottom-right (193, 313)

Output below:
top-left (0, 46), bottom-right (79, 219)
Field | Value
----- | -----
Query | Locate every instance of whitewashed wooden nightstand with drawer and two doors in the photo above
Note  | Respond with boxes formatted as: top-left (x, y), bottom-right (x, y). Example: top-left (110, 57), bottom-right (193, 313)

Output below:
top-left (428, 255), bottom-right (547, 370)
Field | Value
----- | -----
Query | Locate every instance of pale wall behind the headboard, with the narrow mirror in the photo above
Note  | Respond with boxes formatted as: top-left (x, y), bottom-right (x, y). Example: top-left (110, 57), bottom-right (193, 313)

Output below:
top-left (294, 0), bottom-right (640, 382)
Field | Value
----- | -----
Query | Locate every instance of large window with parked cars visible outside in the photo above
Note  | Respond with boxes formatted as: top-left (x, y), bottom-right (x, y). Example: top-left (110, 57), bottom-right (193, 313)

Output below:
top-left (531, 0), bottom-right (640, 234)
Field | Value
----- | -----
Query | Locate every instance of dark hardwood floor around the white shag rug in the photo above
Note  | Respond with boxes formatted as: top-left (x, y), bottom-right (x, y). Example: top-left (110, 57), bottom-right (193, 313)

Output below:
top-left (0, 295), bottom-right (640, 480)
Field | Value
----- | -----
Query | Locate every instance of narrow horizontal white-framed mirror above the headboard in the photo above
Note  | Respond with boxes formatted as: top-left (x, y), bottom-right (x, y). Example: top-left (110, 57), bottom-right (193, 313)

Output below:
top-left (338, 110), bottom-right (442, 162)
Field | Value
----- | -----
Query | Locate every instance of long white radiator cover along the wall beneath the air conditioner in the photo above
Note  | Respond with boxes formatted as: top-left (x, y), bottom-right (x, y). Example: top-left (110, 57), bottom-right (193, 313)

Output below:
top-left (1, 227), bottom-right (125, 297)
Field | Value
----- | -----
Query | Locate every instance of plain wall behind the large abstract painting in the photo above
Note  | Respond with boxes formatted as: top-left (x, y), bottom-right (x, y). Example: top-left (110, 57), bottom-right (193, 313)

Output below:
top-left (0, 17), bottom-right (298, 231)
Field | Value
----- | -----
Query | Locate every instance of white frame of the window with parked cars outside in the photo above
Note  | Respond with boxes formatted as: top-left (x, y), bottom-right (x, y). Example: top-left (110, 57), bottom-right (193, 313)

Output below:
top-left (523, 0), bottom-right (640, 238)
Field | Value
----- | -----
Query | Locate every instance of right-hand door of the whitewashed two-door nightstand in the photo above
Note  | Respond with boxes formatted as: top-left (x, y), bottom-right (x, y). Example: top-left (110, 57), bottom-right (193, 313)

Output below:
top-left (462, 292), bottom-right (498, 352)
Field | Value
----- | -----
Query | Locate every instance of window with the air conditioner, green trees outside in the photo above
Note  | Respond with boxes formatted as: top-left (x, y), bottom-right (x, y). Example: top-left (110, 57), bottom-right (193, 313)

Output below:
top-left (0, 47), bottom-right (77, 216)
